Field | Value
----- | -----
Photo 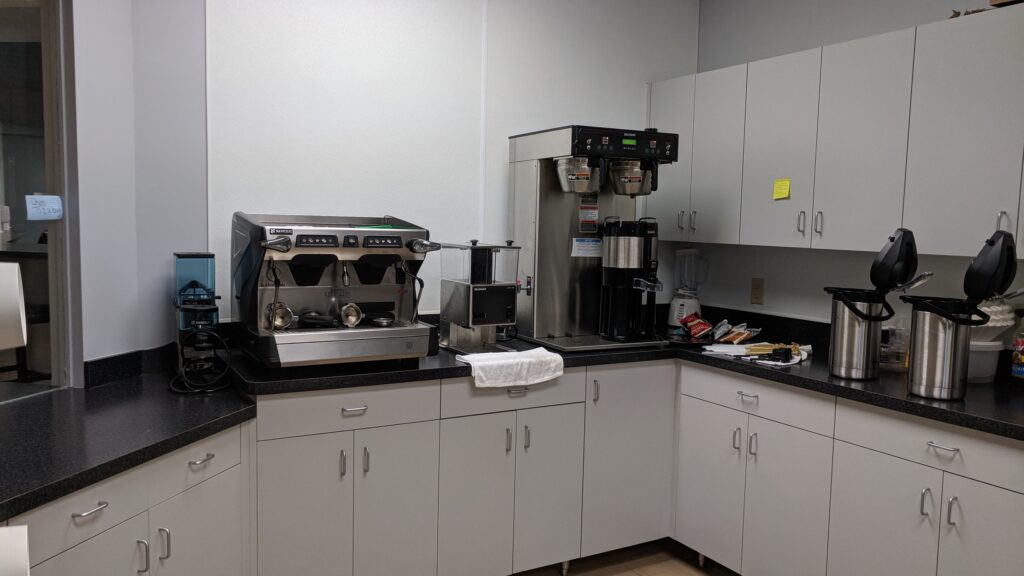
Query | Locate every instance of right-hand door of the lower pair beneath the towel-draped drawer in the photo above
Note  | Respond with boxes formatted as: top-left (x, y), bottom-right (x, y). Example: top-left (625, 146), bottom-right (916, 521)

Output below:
top-left (512, 404), bottom-right (585, 572)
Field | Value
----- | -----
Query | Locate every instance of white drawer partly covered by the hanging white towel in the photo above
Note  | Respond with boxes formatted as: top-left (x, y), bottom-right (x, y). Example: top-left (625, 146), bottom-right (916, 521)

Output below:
top-left (441, 368), bottom-right (587, 418)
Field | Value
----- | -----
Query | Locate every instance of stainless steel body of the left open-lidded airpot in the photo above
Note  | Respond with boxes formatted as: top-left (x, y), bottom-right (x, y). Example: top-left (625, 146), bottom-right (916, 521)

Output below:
top-left (828, 297), bottom-right (883, 380)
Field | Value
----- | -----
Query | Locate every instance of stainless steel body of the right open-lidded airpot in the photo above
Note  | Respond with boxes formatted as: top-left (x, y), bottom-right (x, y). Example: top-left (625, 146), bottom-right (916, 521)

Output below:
top-left (908, 310), bottom-right (971, 400)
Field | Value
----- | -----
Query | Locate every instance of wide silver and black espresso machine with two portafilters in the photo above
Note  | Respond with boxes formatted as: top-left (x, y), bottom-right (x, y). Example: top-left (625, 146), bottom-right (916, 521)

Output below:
top-left (231, 212), bottom-right (440, 367)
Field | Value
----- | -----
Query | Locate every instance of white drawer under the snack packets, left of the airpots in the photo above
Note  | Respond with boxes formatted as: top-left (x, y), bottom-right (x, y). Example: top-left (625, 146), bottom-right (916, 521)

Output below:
top-left (679, 364), bottom-right (836, 437)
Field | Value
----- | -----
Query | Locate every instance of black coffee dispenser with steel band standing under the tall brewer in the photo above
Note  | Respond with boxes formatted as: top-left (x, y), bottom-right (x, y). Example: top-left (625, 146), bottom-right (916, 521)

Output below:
top-left (599, 216), bottom-right (662, 341)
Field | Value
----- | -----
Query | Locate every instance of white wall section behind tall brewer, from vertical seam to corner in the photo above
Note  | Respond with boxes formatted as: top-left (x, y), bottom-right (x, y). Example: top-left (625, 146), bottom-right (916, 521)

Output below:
top-left (481, 0), bottom-right (698, 242)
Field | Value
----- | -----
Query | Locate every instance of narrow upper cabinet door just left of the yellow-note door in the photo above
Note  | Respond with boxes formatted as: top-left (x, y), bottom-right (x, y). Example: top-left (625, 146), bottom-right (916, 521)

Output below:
top-left (688, 64), bottom-right (746, 244)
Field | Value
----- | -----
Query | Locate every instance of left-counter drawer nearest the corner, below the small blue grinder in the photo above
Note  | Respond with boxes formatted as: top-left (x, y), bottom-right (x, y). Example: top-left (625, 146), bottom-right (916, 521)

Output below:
top-left (139, 426), bottom-right (242, 506)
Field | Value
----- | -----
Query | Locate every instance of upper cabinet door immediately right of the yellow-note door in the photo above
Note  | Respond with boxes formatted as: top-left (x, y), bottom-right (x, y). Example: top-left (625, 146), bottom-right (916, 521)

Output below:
top-left (811, 28), bottom-right (914, 251)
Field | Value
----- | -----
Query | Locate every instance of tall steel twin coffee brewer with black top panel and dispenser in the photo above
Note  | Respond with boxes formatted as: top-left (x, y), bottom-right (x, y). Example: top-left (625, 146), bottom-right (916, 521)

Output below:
top-left (508, 125), bottom-right (679, 352)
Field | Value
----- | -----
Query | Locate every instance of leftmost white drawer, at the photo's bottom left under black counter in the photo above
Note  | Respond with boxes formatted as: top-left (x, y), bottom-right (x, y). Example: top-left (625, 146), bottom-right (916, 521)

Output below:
top-left (10, 468), bottom-right (148, 566)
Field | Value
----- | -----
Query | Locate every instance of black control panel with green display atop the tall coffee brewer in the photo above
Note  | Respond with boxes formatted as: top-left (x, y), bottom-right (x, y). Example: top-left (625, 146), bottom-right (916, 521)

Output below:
top-left (572, 126), bottom-right (679, 163)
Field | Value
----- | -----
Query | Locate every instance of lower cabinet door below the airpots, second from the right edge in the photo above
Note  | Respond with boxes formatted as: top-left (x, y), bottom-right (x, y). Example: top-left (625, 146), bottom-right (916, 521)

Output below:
top-left (828, 442), bottom-right (942, 576)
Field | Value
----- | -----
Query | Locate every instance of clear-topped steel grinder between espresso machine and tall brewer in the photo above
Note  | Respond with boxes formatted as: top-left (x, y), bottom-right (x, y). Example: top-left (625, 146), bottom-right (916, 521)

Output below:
top-left (438, 240), bottom-right (519, 354)
